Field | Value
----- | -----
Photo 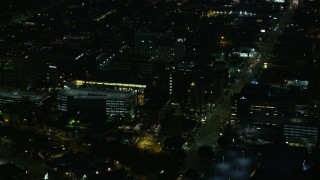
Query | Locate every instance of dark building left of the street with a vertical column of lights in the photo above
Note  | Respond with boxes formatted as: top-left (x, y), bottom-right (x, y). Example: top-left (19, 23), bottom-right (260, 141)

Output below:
top-left (165, 62), bottom-right (227, 109)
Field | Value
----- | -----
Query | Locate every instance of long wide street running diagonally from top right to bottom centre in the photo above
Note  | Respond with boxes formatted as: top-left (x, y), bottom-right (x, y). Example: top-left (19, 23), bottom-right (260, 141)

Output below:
top-left (184, 1), bottom-right (298, 174)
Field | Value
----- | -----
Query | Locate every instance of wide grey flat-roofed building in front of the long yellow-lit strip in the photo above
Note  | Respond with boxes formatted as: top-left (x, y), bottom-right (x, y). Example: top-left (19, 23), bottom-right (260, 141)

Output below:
top-left (58, 82), bottom-right (137, 118)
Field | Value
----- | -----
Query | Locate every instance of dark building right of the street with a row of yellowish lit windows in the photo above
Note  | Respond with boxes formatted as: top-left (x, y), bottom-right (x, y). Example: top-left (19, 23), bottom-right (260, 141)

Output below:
top-left (231, 84), bottom-right (309, 125)
